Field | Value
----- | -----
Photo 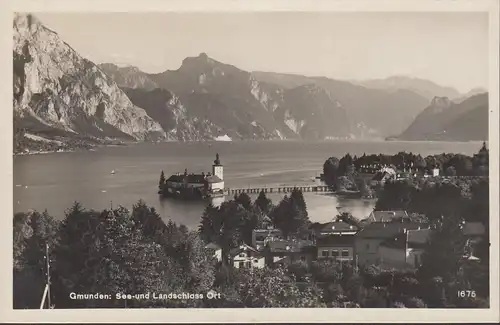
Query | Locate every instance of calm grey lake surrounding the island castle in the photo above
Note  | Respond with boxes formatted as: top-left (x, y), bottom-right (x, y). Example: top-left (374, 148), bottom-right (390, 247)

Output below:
top-left (13, 141), bottom-right (481, 228)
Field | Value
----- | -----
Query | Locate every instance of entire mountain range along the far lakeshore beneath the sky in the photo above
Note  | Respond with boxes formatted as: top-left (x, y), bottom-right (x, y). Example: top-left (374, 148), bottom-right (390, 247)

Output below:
top-left (13, 14), bottom-right (488, 153)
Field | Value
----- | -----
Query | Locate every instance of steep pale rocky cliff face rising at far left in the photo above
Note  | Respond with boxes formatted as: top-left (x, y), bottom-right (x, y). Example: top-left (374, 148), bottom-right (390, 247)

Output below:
top-left (13, 14), bottom-right (165, 151)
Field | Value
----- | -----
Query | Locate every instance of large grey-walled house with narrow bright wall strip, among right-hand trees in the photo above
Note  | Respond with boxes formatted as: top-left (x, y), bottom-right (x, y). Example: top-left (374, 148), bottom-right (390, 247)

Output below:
top-left (378, 228), bottom-right (431, 270)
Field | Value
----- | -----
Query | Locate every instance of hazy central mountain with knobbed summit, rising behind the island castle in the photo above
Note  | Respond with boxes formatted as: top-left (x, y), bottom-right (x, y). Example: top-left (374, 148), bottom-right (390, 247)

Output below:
top-left (104, 53), bottom-right (351, 139)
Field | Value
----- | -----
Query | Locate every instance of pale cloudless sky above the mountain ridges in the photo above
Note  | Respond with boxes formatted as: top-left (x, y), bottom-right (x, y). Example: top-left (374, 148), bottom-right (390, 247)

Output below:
top-left (35, 12), bottom-right (488, 93)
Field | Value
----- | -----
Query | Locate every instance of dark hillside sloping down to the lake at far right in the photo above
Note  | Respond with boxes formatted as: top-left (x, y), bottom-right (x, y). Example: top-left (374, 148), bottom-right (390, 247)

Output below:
top-left (398, 93), bottom-right (488, 141)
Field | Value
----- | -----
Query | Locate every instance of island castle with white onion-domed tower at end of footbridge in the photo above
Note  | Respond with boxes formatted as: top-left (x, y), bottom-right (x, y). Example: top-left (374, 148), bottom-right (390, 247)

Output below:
top-left (159, 153), bottom-right (224, 199)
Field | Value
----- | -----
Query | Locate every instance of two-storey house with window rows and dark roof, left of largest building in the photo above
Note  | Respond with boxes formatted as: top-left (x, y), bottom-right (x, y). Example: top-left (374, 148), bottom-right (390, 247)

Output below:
top-left (316, 221), bottom-right (359, 261)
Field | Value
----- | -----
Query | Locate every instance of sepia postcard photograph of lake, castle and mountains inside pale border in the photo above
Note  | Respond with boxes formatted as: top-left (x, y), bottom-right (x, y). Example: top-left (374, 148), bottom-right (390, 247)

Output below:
top-left (2, 1), bottom-right (498, 320)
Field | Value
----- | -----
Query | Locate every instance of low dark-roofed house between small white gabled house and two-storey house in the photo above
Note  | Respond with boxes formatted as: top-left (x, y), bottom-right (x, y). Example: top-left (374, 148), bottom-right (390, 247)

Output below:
top-left (264, 239), bottom-right (316, 267)
